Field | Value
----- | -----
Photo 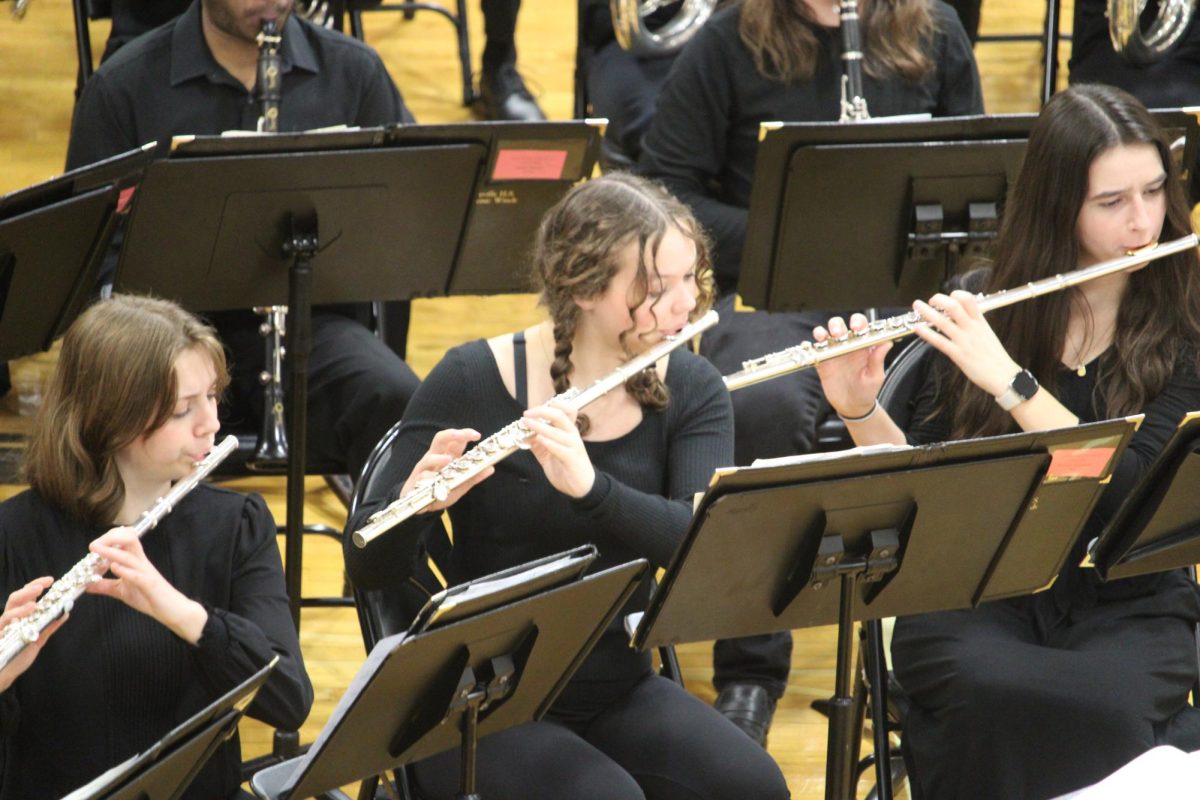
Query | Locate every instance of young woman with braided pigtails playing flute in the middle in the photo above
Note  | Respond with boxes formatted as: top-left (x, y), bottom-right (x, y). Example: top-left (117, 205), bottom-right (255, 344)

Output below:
top-left (346, 174), bottom-right (787, 800)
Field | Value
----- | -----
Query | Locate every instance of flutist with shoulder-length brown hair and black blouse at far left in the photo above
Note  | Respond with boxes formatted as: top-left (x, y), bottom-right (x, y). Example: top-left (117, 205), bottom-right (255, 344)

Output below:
top-left (0, 295), bottom-right (313, 800)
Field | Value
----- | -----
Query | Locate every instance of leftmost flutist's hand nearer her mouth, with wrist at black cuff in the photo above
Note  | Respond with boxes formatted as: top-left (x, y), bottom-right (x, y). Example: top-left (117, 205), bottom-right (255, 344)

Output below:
top-left (88, 528), bottom-right (209, 644)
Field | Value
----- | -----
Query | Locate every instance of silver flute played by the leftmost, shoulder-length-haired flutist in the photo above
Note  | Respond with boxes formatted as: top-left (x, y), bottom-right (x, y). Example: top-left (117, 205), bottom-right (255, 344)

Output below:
top-left (0, 437), bottom-right (238, 669)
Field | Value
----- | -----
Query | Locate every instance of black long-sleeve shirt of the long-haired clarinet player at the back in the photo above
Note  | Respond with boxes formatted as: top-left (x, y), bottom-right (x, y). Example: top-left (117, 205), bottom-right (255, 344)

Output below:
top-left (638, 1), bottom-right (983, 290)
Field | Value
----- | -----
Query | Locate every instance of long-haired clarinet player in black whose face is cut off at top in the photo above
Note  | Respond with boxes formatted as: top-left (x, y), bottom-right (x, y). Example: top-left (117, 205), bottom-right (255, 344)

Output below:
top-left (638, 0), bottom-right (983, 740)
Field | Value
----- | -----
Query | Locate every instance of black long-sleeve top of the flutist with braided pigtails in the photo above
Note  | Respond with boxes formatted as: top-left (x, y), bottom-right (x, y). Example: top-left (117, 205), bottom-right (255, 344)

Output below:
top-left (346, 341), bottom-right (733, 681)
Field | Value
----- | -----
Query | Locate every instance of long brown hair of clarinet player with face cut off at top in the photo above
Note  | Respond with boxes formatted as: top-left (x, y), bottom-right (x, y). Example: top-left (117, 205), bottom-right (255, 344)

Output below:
top-left (738, 0), bottom-right (937, 83)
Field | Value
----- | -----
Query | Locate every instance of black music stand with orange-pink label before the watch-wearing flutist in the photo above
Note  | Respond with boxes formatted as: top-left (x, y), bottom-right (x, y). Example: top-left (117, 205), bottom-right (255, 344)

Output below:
top-left (634, 420), bottom-right (1134, 800)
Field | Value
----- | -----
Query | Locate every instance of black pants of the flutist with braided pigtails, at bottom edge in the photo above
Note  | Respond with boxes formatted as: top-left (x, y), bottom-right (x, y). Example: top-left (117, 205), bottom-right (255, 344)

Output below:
top-left (414, 675), bottom-right (788, 800)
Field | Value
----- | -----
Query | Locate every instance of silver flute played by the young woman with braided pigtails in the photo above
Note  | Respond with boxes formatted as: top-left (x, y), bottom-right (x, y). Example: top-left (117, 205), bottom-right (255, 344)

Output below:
top-left (352, 311), bottom-right (718, 547)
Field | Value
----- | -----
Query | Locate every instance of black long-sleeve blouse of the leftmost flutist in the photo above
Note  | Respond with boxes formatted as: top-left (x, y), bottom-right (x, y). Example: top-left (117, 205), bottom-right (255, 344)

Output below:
top-left (0, 486), bottom-right (313, 800)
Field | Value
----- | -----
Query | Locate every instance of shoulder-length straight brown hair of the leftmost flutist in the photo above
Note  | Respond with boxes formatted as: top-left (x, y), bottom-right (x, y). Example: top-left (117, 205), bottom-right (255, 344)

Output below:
top-left (23, 295), bottom-right (229, 525)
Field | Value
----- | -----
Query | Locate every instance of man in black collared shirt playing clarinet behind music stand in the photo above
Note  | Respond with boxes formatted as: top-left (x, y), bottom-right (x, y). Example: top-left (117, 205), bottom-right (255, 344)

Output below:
top-left (67, 0), bottom-right (418, 475)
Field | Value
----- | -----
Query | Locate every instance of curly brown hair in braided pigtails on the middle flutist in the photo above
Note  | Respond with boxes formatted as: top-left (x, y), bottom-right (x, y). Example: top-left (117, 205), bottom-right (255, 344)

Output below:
top-left (533, 173), bottom-right (713, 433)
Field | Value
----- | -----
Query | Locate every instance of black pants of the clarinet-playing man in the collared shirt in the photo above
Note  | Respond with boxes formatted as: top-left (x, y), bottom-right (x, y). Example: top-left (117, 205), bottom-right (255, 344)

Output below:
top-left (212, 311), bottom-right (420, 477)
